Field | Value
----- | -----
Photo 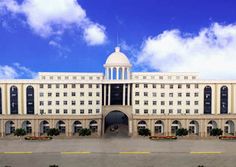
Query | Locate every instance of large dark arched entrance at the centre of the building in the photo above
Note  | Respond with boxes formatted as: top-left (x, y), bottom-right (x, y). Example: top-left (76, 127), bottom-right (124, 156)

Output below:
top-left (104, 111), bottom-right (129, 137)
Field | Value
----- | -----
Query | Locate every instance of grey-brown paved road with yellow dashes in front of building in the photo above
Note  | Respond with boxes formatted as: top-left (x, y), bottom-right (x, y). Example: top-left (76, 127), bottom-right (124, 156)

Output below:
top-left (0, 138), bottom-right (236, 167)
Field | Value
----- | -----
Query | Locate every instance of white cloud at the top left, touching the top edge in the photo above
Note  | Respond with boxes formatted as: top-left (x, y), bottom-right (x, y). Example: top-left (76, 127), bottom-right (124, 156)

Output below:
top-left (0, 0), bottom-right (106, 45)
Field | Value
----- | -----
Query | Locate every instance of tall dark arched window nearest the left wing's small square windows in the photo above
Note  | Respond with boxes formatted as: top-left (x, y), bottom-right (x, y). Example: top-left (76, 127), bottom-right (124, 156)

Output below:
top-left (26, 86), bottom-right (34, 114)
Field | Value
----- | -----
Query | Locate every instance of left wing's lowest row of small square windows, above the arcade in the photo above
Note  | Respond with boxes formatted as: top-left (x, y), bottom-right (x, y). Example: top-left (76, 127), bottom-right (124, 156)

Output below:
top-left (40, 109), bottom-right (100, 114)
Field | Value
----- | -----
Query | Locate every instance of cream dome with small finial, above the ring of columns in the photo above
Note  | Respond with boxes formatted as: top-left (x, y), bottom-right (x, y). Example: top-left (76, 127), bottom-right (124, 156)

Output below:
top-left (104, 47), bottom-right (131, 67)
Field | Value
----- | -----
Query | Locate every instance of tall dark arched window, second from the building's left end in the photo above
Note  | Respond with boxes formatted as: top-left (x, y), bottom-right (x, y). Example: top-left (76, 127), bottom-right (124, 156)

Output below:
top-left (10, 86), bottom-right (18, 114)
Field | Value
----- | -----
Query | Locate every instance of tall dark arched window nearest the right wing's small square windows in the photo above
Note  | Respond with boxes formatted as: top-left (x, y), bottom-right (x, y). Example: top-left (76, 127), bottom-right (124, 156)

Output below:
top-left (204, 86), bottom-right (212, 114)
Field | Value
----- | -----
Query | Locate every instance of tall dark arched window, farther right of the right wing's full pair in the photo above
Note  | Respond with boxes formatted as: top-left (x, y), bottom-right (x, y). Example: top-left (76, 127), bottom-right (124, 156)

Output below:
top-left (220, 86), bottom-right (228, 114)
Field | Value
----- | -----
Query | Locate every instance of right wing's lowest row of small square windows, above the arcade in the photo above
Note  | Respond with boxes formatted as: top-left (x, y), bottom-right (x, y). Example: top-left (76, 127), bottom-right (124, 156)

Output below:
top-left (135, 109), bottom-right (198, 114)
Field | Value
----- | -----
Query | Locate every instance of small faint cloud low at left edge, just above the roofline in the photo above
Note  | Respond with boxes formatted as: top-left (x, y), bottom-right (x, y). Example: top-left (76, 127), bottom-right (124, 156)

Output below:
top-left (0, 63), bottom-right (38, 79)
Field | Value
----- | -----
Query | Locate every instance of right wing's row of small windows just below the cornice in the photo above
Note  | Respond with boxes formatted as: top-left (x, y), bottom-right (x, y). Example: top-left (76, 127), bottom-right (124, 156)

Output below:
top-left (135, 84), bottom-right (199, 89)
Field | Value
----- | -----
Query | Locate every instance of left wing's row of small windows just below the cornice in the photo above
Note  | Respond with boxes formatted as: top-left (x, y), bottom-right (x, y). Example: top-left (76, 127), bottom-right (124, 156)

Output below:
top-left (39, 84), bottom-right (100, 89)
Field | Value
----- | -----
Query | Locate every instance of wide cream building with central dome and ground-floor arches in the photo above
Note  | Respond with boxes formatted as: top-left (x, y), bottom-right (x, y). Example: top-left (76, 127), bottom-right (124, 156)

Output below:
top-left (0, 47), bottom-right (236, 137)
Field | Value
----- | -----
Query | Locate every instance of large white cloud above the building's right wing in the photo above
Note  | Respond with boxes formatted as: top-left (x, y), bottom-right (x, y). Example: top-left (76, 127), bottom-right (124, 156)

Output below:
top-left (136, 23), bottom-right (236, 79)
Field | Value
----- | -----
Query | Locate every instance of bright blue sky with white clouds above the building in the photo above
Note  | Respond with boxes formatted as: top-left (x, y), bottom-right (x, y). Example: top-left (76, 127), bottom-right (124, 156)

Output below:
top-left (0, 0), bottom-right (236, 79)
